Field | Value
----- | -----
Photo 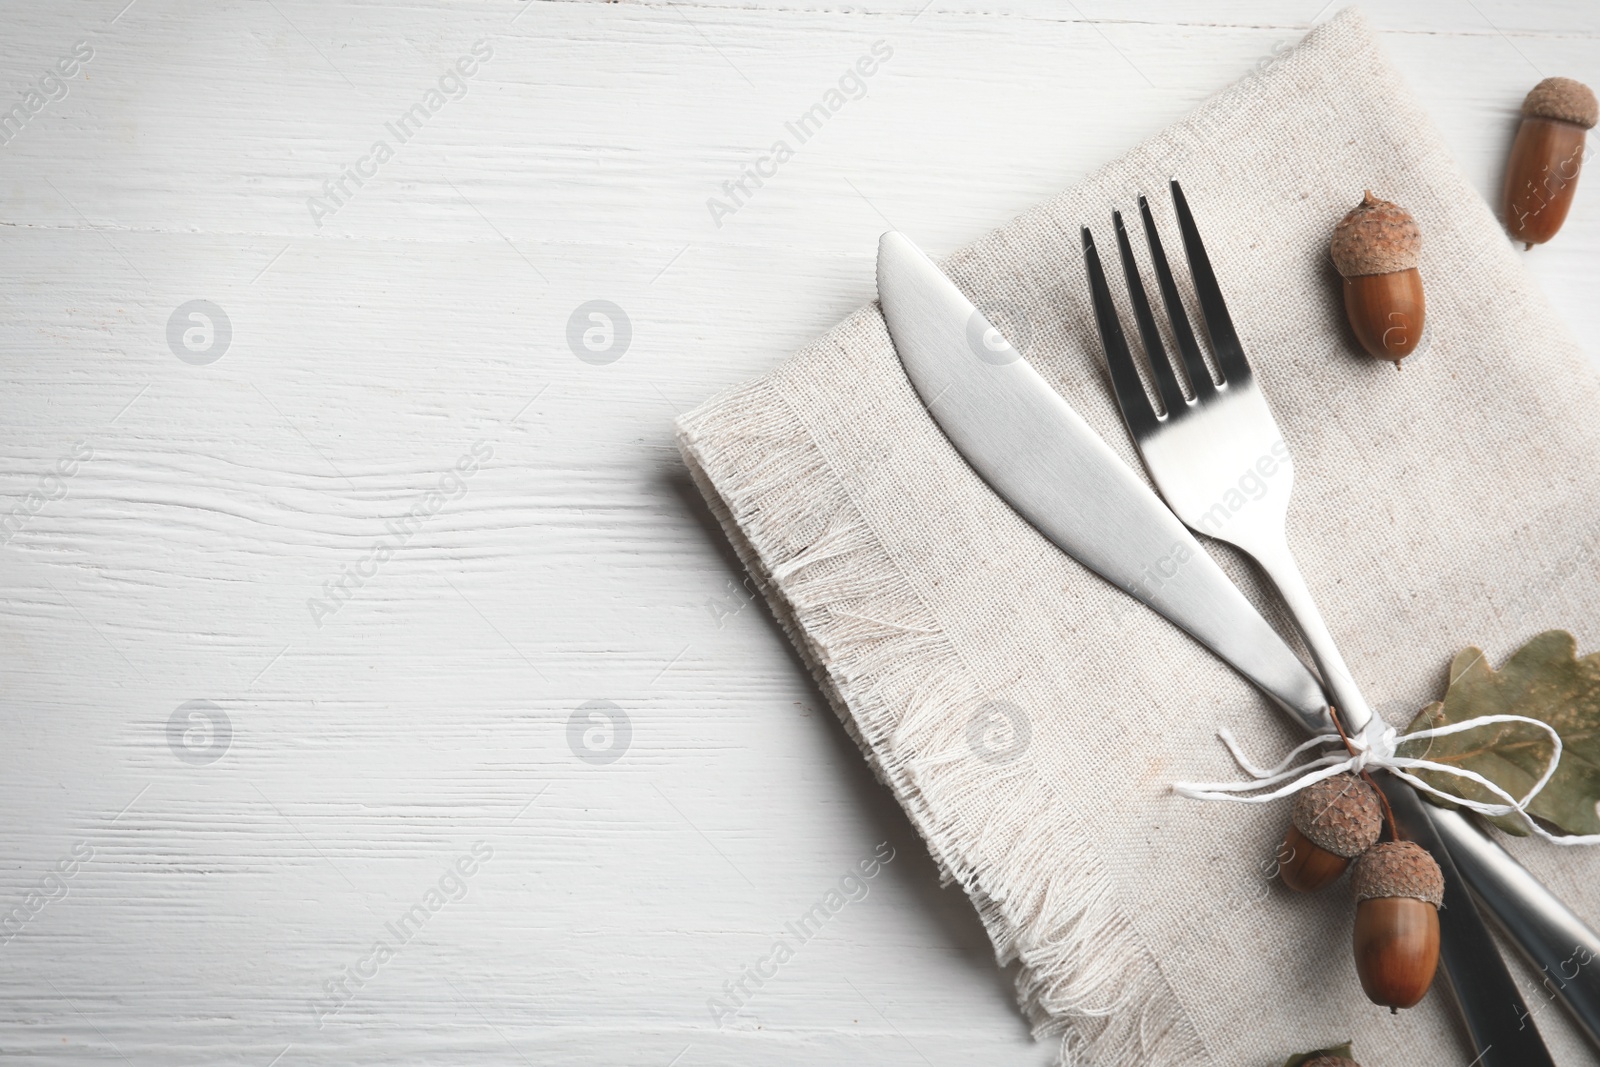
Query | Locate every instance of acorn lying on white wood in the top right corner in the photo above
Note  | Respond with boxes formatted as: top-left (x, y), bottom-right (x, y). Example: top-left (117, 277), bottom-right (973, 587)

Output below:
top-left (1506, 78), bottom-right (1600, 250)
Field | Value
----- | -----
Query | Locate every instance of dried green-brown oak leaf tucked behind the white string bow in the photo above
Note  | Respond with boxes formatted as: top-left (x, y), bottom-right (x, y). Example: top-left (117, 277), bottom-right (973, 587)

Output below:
top-left (1398, 630), bottom-right (1600, 837)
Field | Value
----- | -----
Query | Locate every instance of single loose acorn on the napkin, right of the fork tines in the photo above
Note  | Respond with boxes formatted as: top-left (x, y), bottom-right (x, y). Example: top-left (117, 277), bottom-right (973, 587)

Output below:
top-left (1328, 190), bottom-right (1426, 370)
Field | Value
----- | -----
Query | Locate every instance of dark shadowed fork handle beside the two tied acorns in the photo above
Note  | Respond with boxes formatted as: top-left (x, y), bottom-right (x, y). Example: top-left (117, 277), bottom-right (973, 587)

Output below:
top-left (1376, 774), bottom-right (1555, 1067)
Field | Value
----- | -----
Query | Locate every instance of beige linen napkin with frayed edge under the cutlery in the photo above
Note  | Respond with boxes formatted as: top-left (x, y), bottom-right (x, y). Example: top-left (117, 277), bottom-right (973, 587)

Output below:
top-left (678, 11), bottom-right (1600, 1067)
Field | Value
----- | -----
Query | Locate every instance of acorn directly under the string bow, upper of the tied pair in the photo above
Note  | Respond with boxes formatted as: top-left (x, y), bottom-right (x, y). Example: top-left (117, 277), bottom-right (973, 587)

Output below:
top-left (1278, 774), bottom-right (1384, 893)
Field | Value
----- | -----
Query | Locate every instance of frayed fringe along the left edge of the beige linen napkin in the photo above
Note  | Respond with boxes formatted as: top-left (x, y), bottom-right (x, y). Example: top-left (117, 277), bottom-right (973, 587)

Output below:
top-left (678, 377), bottom-right (1205, 1067)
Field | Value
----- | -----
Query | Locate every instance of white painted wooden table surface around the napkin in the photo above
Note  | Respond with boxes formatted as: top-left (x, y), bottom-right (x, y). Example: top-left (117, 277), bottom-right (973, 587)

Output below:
top-left (0, 0), bottom-right (1600, 1067)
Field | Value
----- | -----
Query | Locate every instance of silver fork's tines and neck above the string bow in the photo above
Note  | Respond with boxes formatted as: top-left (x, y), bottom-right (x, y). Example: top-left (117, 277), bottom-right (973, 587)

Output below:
top-left (1083, 181), bottom-right (1381, 737)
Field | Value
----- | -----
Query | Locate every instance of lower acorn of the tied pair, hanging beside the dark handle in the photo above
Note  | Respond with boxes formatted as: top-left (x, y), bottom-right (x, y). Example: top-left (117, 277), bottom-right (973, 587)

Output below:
top-left (1352, 841), bottom-right (1445, 1011)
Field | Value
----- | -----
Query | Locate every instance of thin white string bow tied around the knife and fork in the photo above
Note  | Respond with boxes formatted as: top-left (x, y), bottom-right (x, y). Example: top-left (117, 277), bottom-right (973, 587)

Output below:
top-left (1173, 715), bottom-right (1600, 845)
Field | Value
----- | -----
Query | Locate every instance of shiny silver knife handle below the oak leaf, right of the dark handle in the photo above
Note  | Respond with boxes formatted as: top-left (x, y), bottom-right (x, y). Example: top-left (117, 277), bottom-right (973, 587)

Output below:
top-left (1429, 805), bottom-right (1600, 1048)
